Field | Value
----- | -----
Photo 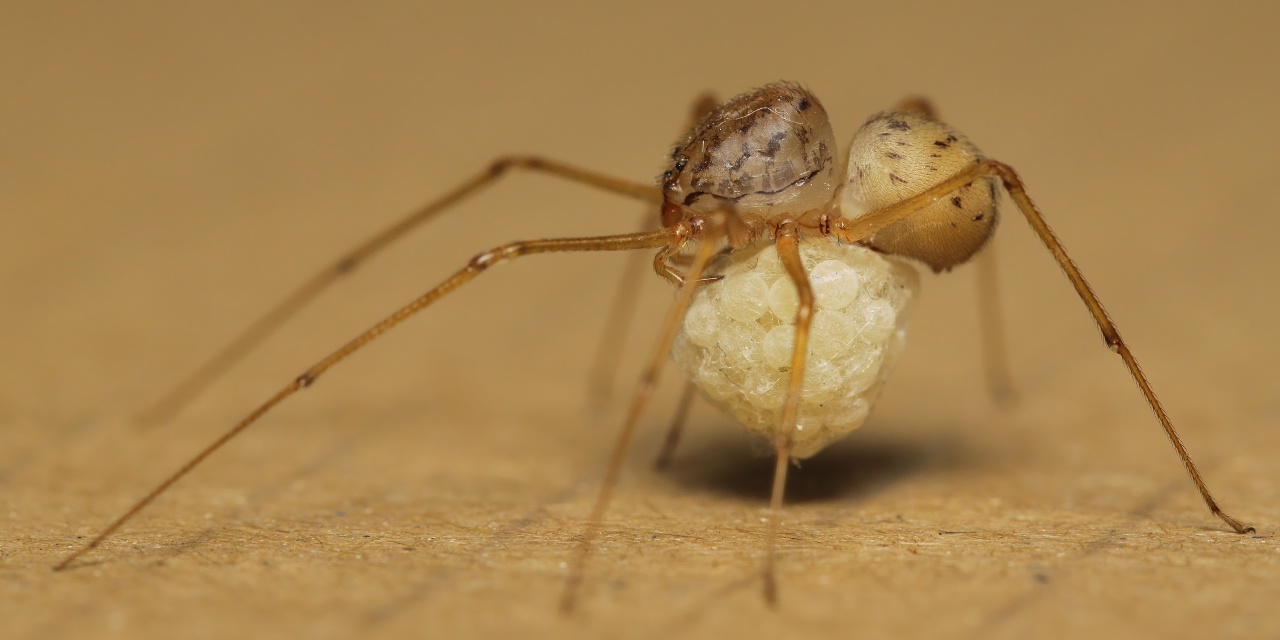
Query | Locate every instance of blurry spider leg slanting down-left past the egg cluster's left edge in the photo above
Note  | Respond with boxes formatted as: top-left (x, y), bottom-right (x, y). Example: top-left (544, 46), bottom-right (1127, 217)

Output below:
top-left (561, 220), bottom-right (724, 613)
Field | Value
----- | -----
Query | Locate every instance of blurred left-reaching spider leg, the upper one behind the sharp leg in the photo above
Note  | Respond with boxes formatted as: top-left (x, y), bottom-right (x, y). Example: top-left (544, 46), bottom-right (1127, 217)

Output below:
top-left (138, 156), bottom-right (662, 424)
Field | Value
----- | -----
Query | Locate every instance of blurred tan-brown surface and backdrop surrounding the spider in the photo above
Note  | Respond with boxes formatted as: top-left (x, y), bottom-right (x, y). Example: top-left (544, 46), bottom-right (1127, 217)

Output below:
top-left (0, 3), bottom-right (1280, 637)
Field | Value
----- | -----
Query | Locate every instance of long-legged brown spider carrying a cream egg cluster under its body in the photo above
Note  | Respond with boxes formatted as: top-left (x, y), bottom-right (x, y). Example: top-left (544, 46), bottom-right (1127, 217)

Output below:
top-left (54, 82), bottom-right (1253, 611)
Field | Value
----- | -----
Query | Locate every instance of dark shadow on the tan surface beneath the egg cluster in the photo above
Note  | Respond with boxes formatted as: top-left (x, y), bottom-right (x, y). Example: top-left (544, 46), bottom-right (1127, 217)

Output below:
top-left (662, 425), bottom-right (980, 504)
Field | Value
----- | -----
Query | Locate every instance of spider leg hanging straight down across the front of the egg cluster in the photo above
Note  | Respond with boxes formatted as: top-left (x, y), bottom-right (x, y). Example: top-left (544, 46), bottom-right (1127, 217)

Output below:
top-left (764, 223), bottom-right (813, 607)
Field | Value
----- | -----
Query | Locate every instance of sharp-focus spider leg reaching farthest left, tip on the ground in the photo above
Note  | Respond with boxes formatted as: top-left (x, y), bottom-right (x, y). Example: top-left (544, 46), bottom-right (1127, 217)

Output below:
top-left (54, 227), bottom-right (689, 571)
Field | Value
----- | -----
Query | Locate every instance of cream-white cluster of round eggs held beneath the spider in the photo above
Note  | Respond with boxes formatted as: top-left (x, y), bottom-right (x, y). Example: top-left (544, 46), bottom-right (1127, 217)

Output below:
top-left (672, 239), bottom-right (919, 460)
